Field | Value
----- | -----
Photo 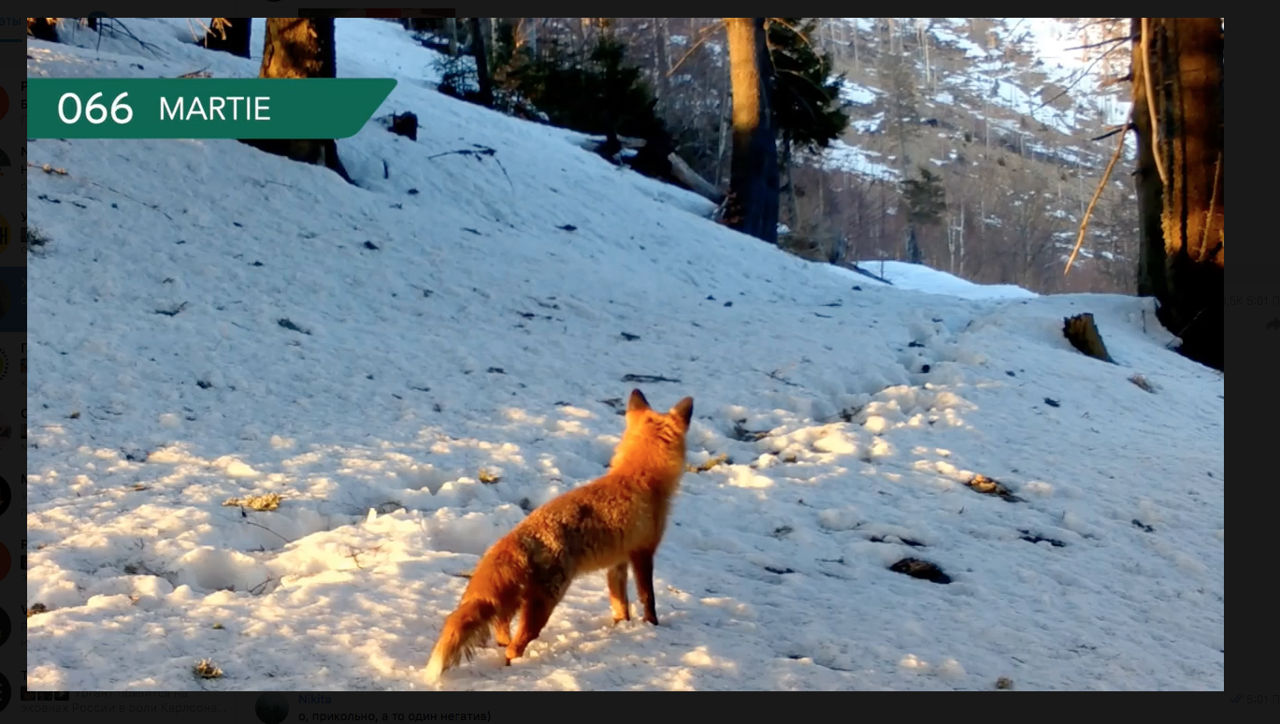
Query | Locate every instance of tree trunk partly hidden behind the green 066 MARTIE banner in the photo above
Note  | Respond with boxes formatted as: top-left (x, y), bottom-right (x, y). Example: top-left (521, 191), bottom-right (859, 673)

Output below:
top-left (246, 18), bottom-right (353, 183)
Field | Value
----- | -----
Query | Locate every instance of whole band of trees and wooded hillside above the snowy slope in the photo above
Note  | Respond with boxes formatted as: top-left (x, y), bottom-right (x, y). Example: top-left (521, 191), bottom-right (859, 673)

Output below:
top-left (27, 17), bottom-right (1226, 370)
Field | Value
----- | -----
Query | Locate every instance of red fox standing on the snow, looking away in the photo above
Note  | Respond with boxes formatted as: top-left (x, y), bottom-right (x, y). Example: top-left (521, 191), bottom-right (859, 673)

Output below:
top-left (426, 390), bottom-right (694, 682)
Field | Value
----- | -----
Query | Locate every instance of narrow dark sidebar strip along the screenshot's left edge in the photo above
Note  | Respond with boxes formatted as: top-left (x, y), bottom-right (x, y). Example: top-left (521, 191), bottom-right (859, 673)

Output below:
top-left (0, 17), bottom-right (27, 720)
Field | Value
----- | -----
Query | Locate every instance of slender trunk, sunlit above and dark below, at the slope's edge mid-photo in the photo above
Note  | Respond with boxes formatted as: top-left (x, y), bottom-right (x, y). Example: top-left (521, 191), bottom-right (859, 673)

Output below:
top-left (724, 18), bottom-right (778, 244)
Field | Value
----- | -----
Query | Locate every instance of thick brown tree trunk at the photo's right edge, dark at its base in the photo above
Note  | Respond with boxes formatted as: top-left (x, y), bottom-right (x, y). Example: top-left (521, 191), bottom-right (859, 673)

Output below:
top-left (1133, 18), bottom-right (1226, 370)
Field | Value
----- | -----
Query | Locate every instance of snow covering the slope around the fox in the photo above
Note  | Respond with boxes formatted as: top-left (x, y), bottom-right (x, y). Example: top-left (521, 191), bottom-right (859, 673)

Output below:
top-left (27, 14), bottom-right (1225, 691)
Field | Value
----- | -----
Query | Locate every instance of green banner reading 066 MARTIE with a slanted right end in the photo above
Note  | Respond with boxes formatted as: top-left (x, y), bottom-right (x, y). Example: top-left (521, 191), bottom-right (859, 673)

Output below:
top-left (27, 78), bottom-right (396, 138)
